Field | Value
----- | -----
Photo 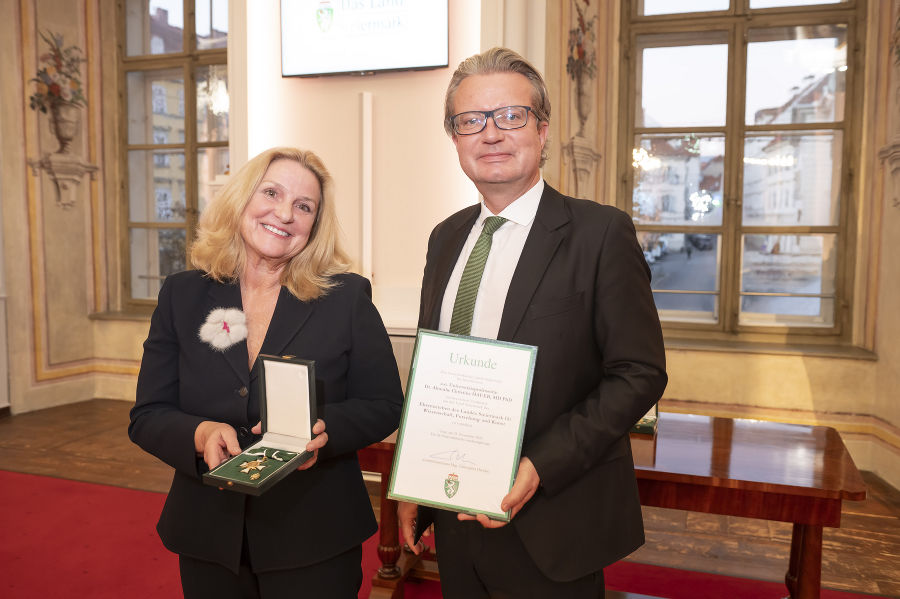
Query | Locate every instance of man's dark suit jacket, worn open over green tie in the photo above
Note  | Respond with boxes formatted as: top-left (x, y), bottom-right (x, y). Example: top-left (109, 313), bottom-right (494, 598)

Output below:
top-left (419, 185), bottom-right (667, 581)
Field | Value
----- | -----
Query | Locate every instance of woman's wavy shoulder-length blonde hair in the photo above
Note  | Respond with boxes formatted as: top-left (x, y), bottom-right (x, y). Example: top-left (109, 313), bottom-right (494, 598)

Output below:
top-left (191, 147), bottom-right (350, 301)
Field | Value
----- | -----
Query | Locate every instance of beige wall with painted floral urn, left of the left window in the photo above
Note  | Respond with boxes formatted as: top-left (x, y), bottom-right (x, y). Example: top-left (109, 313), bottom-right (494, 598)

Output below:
top-left (8, 0), bottom-right (132, 396)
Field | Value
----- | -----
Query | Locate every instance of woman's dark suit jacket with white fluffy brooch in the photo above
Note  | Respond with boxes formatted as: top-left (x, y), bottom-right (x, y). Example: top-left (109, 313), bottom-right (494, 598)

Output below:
top-left (128, 271), bottom-right (403, 571)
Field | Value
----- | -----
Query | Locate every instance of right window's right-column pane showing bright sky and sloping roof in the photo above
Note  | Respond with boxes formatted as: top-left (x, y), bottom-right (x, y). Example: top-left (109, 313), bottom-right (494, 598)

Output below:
top-left (745, 25), bottom-right (847, 125)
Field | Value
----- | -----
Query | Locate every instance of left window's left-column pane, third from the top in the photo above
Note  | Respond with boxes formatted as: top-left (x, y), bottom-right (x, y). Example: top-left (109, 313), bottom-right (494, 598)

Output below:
top-left (128, 150), bottom-right (185, 223)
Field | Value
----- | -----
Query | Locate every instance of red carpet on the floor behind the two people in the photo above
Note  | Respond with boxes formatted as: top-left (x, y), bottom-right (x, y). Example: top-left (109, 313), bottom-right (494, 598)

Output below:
top-left (0, 470), bottom-right (874, 599)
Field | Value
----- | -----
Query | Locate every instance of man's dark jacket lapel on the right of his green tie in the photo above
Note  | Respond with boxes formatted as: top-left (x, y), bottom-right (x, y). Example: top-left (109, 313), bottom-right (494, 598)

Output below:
top-left (497, 185), bottom-right (570, 340)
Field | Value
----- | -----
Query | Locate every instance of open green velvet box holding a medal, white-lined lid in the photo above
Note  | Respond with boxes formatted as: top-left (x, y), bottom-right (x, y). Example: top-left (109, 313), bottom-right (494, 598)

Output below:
top-left (203, 354), bottom-right (316, 495)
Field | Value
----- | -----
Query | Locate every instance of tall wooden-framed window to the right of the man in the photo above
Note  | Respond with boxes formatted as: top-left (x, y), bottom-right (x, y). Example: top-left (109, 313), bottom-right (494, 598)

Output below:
top-left (621, 0), bottom-right (864, 341)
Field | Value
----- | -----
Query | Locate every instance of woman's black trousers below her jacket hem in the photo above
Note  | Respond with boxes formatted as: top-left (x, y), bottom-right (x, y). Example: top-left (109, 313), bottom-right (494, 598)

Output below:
top-left (178, 542), bottom-right (362, 599)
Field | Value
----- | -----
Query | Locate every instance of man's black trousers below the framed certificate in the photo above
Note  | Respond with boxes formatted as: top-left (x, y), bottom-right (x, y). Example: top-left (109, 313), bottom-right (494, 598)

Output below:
top-left (434, 510), bottom-right (606, 599)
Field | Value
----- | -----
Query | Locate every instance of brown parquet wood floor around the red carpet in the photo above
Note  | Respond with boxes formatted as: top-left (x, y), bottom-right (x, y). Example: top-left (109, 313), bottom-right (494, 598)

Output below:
top-left (0, 400), bottom-right (900, 599)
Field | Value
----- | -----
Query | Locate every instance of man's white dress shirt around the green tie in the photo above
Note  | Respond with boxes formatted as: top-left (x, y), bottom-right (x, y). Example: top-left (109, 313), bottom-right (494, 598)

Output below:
top-left (438, 179), bottom-right (544, 339)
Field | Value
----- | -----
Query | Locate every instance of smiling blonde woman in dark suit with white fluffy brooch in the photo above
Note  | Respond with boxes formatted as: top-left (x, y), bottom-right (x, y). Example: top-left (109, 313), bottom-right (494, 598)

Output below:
top-left (128, 148), bottom-right (402, 598)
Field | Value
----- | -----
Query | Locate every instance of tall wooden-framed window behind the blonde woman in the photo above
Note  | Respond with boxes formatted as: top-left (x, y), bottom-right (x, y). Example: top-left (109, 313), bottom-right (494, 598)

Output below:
top-left (121, 0), bottom-right (229, 306)
